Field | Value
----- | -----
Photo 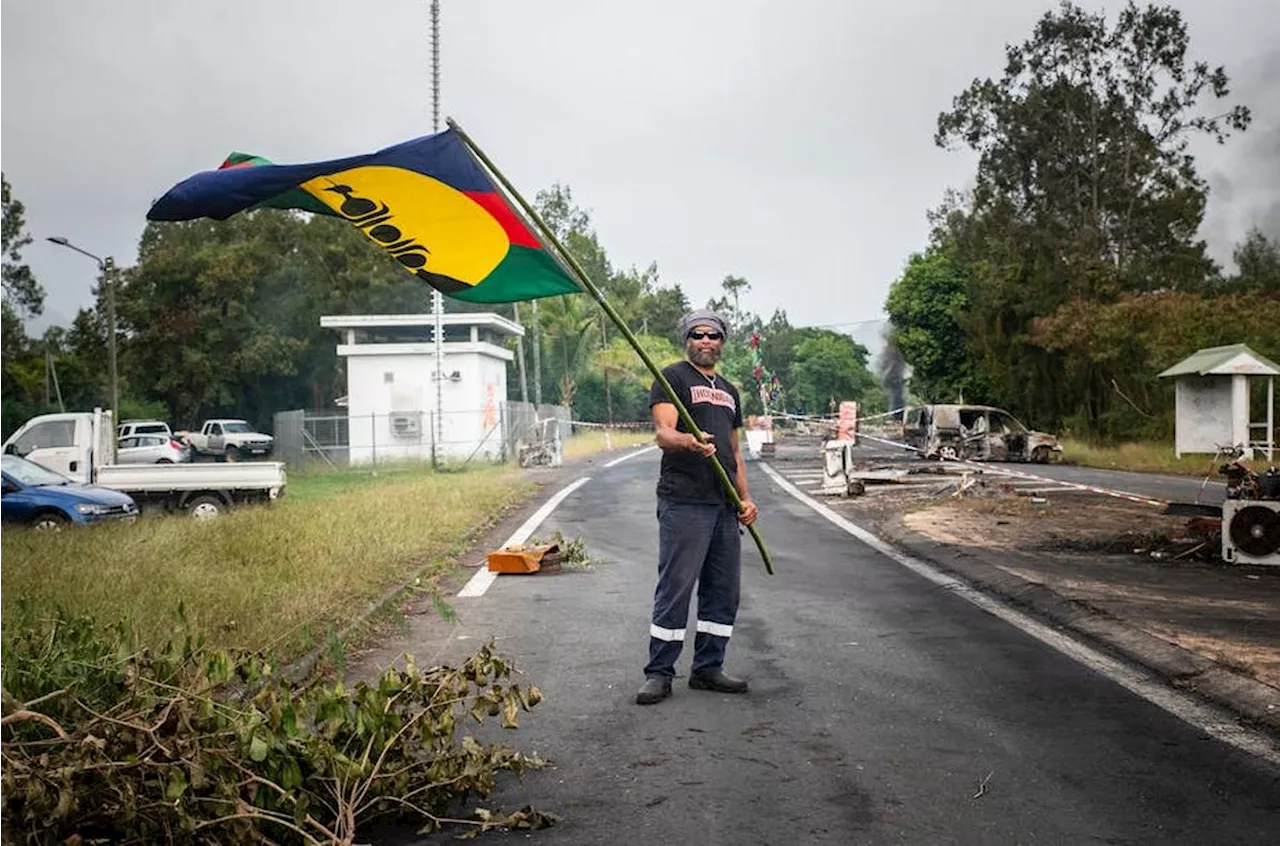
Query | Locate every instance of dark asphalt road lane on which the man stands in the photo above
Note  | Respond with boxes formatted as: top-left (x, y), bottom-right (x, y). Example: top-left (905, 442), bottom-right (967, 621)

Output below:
top-left (394, 453), bottom-right (1280, 846)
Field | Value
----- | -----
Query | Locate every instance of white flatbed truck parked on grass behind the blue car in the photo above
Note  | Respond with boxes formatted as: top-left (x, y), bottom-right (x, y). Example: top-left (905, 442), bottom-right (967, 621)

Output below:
top-left (0, 408), bottom-right (285, 520)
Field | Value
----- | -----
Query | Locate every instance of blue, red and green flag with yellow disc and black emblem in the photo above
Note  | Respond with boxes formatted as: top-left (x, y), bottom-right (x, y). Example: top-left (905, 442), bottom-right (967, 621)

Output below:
top-left (147, 128), bottom-right (581, 302)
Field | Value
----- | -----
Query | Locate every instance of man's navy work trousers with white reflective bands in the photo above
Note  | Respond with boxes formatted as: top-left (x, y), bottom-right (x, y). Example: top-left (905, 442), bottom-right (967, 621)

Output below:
top-left (644, 498), bottom-right (742, 678)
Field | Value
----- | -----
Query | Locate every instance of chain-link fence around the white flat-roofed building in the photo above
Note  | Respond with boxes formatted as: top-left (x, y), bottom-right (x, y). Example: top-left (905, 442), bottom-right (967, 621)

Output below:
top-left (274, 402), bottom-right (572, 470)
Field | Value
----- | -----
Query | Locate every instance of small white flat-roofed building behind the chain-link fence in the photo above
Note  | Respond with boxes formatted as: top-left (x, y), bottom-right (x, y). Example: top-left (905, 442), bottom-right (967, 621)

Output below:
top-left (320, 312), bottom-right (525, 465)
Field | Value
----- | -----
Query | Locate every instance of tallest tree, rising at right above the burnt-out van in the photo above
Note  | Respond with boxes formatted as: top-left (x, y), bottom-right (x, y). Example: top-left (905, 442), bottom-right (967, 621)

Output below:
top-left (934, 1), bottom-right (1249, 427)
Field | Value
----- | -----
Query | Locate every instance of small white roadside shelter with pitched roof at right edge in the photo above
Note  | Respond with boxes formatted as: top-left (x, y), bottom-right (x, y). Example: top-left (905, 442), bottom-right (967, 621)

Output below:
top-left (1160, 344), bottom-right (1280, 459)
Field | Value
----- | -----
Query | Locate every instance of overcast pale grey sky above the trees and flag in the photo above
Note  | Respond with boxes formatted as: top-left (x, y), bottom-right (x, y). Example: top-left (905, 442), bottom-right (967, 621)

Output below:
top-left (0, 0), bottom-right (1280, 350)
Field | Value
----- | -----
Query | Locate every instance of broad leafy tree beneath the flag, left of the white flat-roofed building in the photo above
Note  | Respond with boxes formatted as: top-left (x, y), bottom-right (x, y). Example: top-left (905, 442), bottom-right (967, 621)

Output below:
top-left (118, 210), bottom-right (419, 425)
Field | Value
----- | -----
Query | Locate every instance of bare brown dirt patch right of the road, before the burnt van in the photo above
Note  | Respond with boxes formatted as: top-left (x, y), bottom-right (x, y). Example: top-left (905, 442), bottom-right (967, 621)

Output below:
top-left (885, 494), bottom-right (1280, 689)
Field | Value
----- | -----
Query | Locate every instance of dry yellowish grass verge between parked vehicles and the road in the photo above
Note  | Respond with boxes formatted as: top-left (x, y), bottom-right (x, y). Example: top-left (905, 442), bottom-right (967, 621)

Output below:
top-left (0, 466), bottom-right (532, 657)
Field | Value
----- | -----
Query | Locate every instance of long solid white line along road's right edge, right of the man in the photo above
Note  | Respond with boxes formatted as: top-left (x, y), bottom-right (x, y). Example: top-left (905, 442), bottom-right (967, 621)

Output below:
top-left (760, 462), bottom-right (1280, 765)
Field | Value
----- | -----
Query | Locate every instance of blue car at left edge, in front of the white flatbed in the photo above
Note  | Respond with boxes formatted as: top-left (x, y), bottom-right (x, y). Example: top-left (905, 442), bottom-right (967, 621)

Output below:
top-left (0, 456), bottom-right (138, 530)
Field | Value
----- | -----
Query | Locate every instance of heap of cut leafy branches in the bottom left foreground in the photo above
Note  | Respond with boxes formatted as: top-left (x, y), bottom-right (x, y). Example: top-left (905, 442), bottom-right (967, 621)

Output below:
top-left (0, 609), bottom-right (553, 843)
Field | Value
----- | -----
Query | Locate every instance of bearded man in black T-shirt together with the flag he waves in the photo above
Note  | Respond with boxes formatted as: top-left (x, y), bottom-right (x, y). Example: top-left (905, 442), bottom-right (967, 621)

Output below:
top-left (147, 120), bottom-right (773, 680)
